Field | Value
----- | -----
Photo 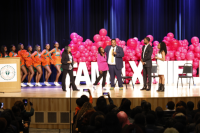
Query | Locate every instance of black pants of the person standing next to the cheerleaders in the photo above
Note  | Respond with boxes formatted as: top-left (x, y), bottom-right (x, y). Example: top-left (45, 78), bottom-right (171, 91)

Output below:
top-left (62, 69), bottom-right (77, 90)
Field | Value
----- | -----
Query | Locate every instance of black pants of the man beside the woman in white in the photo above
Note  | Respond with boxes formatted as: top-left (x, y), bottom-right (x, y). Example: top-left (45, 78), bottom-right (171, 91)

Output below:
top-left (143, 67), bottom-right (151, 89)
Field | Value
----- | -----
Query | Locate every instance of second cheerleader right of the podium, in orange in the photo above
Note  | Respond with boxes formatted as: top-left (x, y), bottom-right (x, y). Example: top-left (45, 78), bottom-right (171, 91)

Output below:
top-left (25, 45), bottom-right (35, 87)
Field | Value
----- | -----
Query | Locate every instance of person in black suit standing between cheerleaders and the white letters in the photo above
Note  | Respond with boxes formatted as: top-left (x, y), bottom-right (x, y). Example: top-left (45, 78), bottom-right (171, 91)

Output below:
top-left (61, 46), bottom-right (79, 91)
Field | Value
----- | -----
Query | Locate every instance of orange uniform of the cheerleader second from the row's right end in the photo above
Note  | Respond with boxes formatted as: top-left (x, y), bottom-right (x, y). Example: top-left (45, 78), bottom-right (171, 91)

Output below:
top-left (41, 50), bottom-right (52, 67)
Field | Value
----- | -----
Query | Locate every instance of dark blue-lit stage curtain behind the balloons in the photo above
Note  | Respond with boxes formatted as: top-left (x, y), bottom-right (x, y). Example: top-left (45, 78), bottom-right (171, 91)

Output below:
top-left (0, 0), bottom-right (200, 81)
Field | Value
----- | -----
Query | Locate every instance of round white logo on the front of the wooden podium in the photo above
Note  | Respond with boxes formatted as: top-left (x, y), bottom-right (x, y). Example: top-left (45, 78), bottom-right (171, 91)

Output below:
top-left (0, 65), bottom-right (16, 80)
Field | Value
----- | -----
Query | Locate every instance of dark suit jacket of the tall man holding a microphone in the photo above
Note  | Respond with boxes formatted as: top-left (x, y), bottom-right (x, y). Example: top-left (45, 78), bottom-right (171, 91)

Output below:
top-left (104, 45), bottom-right (124, 69)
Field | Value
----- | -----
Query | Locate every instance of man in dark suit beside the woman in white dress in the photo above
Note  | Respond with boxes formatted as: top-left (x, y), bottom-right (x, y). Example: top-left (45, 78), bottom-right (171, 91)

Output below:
top-left (141, 37), bottom-right (153, 91)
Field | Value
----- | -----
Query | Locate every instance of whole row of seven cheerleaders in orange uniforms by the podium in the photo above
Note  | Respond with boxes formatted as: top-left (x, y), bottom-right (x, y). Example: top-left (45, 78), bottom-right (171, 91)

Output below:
top-left (0, 41), bottom-right (61, 87)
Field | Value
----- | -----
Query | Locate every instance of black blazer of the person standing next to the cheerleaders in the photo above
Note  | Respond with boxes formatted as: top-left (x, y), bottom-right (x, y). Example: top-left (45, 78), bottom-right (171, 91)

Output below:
top-left (61, 52), bottom-right (74, 70)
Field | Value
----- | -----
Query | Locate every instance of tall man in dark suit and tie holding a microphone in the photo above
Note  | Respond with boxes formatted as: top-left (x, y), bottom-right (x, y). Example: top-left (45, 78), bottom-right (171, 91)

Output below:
top-left (104, 39), bottom-right (124, 90)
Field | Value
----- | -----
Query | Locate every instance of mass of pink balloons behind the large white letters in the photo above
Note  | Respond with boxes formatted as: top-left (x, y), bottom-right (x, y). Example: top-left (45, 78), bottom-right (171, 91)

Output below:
top-left (69, 29), bottom-right (200, 84)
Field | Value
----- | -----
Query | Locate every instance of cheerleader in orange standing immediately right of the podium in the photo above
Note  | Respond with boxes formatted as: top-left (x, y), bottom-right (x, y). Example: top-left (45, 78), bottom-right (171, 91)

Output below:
top-left (18, 43), bottom-right (27, 87)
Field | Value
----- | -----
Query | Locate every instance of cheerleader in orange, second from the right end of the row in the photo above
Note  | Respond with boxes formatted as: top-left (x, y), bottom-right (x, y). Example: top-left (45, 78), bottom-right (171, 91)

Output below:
top-left (41, 44), bottom-right (52, 86)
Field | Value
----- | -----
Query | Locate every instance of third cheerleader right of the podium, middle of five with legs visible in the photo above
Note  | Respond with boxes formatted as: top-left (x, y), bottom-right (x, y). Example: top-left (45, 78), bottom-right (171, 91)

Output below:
top-left (31, 45), bottom-right (43, 86)
